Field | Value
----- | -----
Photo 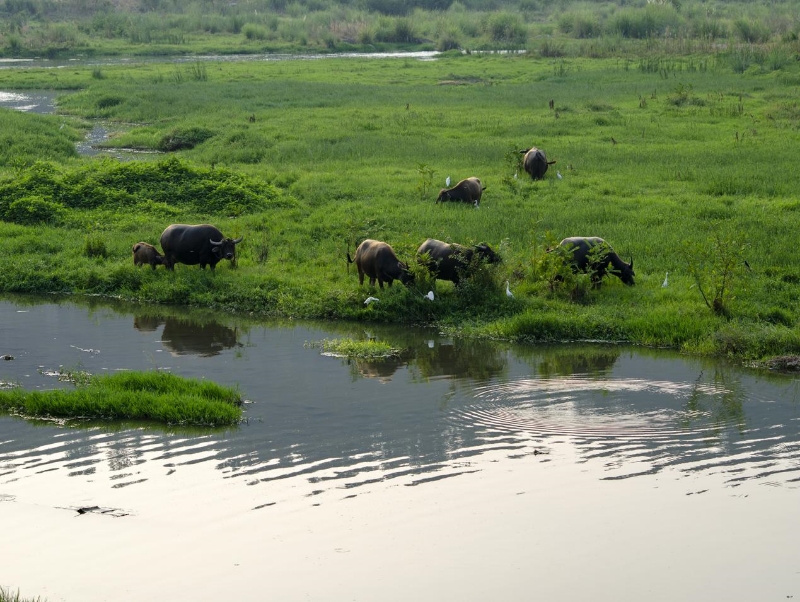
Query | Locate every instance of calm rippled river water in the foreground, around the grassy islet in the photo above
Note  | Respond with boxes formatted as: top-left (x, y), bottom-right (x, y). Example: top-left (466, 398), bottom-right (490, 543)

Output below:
top-left (0, 299), bottom-right (800, 601)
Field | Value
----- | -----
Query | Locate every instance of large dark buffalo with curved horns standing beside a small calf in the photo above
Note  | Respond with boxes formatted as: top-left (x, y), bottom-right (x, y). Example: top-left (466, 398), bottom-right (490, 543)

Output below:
top-left (161, 224), bottom-right (243, 270)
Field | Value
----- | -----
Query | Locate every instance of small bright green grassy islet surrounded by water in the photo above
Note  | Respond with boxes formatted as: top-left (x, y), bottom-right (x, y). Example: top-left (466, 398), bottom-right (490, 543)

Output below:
top-left (0, 372), bottom-right (242, 426)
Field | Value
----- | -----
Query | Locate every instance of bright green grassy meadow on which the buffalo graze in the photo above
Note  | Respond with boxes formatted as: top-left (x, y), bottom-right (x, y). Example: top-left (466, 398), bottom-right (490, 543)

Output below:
top-left (0, 53), bottom-right (800, 358)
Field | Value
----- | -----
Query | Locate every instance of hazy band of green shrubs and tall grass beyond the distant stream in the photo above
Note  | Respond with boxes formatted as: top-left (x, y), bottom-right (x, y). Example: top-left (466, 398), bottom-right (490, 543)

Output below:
top-left (0, 0), bottom-right (800, 56)
